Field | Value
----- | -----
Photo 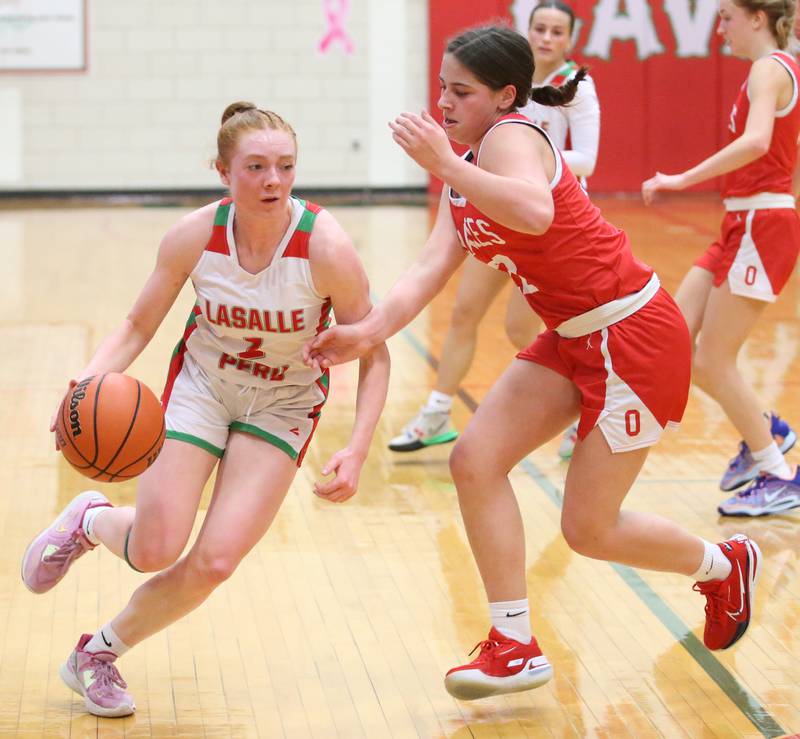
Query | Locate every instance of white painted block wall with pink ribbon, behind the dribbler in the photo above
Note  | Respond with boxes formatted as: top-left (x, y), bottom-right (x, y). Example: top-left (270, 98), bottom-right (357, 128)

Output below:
top-left (0, 0), bottom-right (428, 192)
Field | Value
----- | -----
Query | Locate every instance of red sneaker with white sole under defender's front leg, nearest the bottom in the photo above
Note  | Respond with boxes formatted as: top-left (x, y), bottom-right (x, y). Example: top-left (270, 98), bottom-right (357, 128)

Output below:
top-left (444, 627), bottom-right (553, 701)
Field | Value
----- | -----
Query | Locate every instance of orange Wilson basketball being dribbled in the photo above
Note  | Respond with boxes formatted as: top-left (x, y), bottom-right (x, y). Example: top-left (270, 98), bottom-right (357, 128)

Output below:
top-left (56, 372), bottom-right (166, 482)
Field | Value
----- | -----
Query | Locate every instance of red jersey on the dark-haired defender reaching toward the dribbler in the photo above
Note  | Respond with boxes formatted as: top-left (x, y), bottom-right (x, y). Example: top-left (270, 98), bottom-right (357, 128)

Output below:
top-left (448, 113), bottom-right (653, 328)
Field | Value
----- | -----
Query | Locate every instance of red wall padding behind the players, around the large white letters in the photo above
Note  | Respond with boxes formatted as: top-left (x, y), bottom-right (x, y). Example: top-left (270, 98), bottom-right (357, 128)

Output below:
top-left (429, 0), bottom-right (748, 192)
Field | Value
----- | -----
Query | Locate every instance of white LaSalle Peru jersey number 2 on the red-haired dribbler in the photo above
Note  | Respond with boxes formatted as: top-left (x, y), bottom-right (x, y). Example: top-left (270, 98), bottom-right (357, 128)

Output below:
top-left (170, 198), bottom-right (331, 394)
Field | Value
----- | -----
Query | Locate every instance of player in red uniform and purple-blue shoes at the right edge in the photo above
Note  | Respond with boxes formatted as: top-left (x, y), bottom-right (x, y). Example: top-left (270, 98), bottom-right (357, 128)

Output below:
top-left (642, 0), bottom-right (800, 516)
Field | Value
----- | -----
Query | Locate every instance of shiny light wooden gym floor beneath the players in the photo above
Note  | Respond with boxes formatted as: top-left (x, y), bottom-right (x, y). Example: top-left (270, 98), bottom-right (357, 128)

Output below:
top-left (0, 197), bottom-right (800, 739)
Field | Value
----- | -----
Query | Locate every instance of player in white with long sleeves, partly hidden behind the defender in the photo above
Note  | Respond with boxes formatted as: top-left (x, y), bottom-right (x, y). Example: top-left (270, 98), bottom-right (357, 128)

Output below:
top-left (389, 0), bottom-right (600, 458)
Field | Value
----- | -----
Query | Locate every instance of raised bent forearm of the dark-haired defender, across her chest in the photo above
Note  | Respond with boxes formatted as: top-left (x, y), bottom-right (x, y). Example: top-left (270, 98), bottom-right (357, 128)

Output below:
top-left (441, 157), bottom-right (553, 234)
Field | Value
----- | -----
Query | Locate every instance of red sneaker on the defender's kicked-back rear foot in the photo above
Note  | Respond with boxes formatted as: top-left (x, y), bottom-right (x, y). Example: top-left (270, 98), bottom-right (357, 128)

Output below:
top-left (693, 534), bottom-right (761, 649)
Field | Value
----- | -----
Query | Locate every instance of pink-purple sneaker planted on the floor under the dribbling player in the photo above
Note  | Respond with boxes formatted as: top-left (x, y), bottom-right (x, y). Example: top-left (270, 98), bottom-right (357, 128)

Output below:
top-left (58, 634), bottom-right (136, 718)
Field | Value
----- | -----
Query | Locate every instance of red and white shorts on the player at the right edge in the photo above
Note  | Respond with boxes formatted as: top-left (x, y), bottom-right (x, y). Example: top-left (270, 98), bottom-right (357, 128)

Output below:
top-left (695, 208), bottom-right (800, 303)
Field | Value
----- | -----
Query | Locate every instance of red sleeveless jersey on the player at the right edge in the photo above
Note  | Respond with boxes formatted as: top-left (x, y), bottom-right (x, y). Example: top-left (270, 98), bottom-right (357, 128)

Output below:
top-left (722, 51), bottom-right (800, 198)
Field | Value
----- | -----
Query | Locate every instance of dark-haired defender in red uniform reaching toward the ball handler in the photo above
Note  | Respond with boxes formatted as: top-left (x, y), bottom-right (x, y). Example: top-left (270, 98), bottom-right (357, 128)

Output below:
top-left (304, 26), bottom-right (760, 699)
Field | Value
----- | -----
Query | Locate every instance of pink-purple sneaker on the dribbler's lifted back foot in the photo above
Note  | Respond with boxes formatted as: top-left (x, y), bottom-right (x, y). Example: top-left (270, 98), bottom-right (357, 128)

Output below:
top-left (22, 490), bottom-right (111, 593)
